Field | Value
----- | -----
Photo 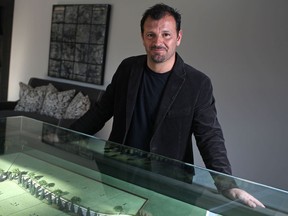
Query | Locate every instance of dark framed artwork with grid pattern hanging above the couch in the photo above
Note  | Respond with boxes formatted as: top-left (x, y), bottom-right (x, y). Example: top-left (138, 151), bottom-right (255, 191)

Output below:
top-left (48, 4), bottom-right (111, 85)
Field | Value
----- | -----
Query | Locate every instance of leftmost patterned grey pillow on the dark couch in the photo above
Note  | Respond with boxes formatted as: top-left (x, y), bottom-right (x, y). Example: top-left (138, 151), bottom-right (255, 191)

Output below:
top-left (14, 82), bottom-right (57, 112)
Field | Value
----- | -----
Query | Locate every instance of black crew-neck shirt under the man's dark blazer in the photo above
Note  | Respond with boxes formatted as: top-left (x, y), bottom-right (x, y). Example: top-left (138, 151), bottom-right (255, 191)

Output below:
top-left (125, 67), bottom-right (170, 151)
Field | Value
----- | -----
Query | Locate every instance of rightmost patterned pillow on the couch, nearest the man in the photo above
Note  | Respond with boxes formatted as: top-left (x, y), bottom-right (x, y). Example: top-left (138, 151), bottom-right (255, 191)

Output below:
top-left (63, 92), bottom-right (91, 119)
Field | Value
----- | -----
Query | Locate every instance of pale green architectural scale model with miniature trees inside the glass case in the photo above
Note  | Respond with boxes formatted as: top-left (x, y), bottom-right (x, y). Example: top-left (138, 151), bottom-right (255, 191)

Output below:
top-left (0, 153), bottom-right (146, 216)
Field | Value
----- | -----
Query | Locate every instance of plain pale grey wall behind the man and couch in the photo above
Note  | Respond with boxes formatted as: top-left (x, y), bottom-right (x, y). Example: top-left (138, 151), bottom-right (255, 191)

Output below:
top-left (8, 0), bottom-right (288, 190)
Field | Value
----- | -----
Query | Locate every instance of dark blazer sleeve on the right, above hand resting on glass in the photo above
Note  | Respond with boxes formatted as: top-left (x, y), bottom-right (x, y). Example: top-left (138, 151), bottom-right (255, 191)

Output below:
top-left (193, 77), bottom-right (232, 174)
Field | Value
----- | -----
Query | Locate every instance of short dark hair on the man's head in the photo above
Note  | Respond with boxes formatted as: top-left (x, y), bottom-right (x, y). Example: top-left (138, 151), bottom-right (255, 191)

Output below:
top-left (140, 3), bottom-right (181, 34)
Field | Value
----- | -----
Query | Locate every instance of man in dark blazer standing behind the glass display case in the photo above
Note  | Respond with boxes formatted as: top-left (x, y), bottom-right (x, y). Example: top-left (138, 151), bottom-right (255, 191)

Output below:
top-left (72, 4), bottom-right (264, 207)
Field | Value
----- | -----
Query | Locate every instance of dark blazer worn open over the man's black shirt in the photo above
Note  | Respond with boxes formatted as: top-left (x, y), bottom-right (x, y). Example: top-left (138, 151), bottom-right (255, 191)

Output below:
top-left (72, 54), bottom-right (231, 174)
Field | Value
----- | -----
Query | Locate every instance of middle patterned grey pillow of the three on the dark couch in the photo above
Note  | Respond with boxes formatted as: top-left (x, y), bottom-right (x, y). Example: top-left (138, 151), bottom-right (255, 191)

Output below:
top-left (40, 89), bottom-right (75, 119)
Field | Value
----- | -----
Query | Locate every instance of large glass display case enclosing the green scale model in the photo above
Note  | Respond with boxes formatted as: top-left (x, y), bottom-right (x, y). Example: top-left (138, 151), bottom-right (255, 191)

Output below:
top-left (0, 117), bottom-right (288, 216)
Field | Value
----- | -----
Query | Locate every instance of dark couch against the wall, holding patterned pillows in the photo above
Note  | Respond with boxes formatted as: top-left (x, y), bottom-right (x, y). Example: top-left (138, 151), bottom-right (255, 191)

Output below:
top-left (0, 77), bottom-right (104, 128)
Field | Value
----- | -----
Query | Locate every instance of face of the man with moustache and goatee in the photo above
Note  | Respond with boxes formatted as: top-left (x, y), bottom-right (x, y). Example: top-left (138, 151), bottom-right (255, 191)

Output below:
top-left (142, 15), bottom-right (182, 64)
